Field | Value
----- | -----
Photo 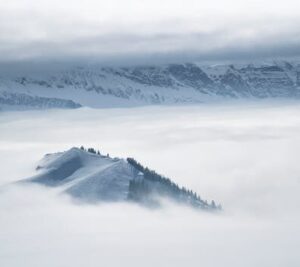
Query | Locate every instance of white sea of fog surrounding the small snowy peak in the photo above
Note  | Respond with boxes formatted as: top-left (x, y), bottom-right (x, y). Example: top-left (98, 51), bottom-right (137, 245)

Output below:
top-left (0, 103), bottom-right (300, 267)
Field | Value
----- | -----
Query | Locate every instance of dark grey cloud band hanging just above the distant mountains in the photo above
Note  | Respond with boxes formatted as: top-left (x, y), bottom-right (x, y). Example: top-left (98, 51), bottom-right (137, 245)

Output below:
top-left (0, 32), bottom-right (300, 64)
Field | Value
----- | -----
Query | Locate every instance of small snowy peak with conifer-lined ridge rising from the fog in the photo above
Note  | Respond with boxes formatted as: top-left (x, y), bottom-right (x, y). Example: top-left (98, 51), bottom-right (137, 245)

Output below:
top-left (20, 147), bottom-right (221, 210)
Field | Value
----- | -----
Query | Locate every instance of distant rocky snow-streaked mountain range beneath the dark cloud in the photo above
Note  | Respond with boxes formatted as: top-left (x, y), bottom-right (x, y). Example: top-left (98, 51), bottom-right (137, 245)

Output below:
top-left (0, 61), bottom-right (300, 109)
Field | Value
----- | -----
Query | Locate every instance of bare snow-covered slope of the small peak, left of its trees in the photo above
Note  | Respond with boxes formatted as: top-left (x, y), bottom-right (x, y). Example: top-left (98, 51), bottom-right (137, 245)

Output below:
top-left (27, 147), bottom-right (135, 202)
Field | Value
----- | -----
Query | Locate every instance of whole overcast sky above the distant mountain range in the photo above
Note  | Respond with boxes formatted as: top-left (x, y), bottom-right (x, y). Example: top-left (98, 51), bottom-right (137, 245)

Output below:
top-left (0, 0), bottom-right (300, 62)
